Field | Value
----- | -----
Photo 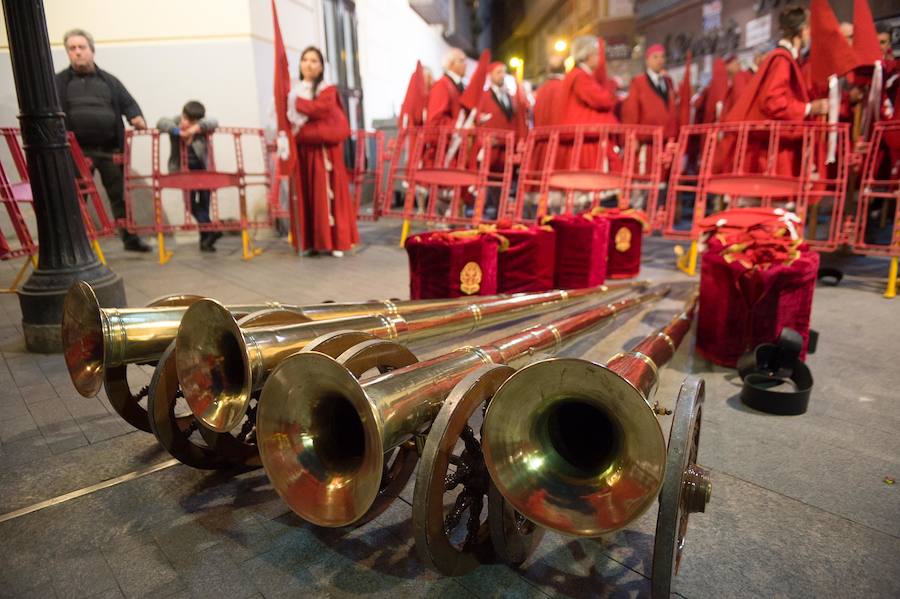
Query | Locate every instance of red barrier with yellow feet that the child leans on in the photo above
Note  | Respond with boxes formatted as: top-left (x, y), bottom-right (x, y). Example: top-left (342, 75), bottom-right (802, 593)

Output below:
top-left (124, 127), bottom-right (272, 264)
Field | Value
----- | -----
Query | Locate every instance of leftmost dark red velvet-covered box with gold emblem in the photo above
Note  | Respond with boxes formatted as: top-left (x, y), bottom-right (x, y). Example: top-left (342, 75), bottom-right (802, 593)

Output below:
top-left (406, 231), bottom-right (500, 299)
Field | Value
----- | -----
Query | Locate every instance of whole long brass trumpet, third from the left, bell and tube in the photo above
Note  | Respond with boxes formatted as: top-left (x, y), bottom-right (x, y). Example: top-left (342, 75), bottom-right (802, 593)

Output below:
top-left (256, 289), bottom-right (668, 527)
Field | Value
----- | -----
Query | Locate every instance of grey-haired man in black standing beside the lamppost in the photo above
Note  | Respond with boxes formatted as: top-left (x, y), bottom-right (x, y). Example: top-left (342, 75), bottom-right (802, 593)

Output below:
top-left (56, 29), bottom-right (150, 252)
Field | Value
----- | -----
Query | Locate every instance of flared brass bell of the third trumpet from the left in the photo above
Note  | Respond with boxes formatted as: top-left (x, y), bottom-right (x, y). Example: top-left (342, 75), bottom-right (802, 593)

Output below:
top-left (256, 351), bottom-right (384, 527)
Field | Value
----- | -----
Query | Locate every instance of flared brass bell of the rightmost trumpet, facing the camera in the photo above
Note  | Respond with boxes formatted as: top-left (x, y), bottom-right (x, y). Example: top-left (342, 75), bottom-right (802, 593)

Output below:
top-left (483, 359), bottom-right (666, 537)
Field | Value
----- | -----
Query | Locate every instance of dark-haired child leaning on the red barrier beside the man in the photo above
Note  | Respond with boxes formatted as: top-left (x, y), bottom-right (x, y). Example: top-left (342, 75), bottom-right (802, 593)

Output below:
top-left (156, 100), bottom-right (222, 252)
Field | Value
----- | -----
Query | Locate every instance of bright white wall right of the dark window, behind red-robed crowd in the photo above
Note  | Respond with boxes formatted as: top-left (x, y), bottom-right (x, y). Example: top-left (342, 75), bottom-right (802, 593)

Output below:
top-left (356, 0), bottom-right (449, 126)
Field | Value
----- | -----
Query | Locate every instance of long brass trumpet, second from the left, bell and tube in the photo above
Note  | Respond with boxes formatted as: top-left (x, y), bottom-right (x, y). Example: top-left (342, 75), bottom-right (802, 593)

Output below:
top-left (175, 281), bottom-right (646, 433)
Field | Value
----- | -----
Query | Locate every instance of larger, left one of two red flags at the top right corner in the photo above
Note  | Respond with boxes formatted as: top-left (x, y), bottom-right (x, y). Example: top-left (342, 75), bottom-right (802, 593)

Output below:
top-left (809, 0), bottom-right (859, 97)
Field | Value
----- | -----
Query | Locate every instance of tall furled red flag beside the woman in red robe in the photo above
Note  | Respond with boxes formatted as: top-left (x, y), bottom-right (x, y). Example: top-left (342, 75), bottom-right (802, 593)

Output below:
top-left (272, 0), bottom-right (303, 252)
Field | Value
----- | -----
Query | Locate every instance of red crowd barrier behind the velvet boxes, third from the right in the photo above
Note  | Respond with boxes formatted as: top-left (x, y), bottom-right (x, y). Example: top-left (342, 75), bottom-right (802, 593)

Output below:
top-left (513, 125), bottom-right (664, 222)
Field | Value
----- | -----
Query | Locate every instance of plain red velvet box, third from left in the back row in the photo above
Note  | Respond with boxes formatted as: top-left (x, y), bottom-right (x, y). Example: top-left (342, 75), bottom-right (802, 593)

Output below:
top-left (545, 215), bottom-right (609, 289)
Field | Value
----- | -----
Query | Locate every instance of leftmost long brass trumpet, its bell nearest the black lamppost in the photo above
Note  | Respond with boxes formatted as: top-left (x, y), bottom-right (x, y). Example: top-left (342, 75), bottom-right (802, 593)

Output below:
top-left (62, 281), bottom-right (556, 397)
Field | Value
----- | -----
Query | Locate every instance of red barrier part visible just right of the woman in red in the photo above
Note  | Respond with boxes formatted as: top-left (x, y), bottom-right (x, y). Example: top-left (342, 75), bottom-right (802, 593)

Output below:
top-left (347, 129), bottom-right (385, 221)
